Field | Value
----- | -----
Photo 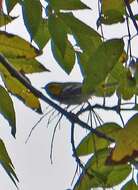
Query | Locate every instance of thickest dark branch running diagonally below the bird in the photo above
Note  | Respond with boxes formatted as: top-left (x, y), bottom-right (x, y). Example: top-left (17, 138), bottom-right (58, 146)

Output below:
top-left (0, 53), bottom-right (114, 142)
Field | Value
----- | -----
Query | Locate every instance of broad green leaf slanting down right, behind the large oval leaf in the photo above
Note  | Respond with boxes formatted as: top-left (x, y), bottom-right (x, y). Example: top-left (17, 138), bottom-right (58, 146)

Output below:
top-left (59, 13), bottom-right (102, 56)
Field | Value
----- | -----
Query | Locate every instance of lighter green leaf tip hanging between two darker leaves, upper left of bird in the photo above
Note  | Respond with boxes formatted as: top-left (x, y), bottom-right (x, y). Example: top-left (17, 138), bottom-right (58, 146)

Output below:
top-left (33, 19), bottom-right (50, 49)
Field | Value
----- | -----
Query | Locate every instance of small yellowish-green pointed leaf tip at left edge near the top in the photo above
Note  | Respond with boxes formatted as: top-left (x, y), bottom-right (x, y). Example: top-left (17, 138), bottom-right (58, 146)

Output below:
top-left (0, 13), bottom-right (17, 27)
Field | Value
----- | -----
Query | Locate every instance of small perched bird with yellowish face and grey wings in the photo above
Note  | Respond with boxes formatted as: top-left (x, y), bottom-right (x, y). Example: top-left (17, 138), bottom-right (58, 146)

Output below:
top-left (44, 82), bottom-right (91, 105)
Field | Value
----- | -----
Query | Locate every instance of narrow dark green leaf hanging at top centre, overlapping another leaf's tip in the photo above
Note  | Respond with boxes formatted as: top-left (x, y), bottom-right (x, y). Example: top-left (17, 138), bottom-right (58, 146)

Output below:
top-left (48, 15), bottom-right (67, 57)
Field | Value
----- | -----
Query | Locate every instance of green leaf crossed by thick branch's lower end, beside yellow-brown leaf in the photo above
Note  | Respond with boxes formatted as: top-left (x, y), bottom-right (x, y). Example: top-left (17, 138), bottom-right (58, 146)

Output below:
top-left (76, 123), bottom-right (121, 156)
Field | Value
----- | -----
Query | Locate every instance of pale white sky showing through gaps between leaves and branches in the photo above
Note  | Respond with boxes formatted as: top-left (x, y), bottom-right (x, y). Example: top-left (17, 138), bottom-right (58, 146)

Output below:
top-left (0, 0), bottom-right (137, 190)
